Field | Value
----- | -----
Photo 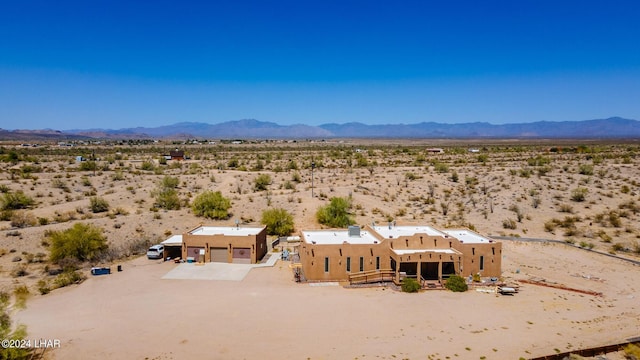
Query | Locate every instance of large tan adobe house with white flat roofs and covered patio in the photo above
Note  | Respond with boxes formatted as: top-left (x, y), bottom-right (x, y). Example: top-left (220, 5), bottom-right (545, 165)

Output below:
top-left (299, 224), bottom-right (502, 284)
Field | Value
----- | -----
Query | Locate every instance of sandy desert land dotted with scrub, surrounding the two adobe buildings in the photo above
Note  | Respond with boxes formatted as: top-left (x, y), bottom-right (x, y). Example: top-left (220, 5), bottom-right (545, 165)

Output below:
top-left (0, 140), bottom-right (640, 359)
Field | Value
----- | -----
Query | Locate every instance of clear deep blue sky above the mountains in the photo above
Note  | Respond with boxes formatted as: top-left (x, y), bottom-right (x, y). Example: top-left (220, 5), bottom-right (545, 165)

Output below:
top-left (0, 0), bottom-right (640, 130)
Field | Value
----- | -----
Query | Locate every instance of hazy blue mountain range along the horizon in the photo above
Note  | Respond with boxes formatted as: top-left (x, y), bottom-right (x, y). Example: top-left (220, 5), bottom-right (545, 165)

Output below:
top-left (0, 117), bottom-right (640, 140)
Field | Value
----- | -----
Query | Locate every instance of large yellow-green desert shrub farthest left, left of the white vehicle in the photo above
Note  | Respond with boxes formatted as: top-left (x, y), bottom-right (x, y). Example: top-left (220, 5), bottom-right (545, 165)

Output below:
top-left (48, 223), bottom-right (108, 263)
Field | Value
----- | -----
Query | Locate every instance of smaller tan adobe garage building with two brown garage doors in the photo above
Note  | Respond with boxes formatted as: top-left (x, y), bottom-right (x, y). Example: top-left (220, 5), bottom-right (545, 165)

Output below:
top-left (182, 226), bottom-right (267, 264)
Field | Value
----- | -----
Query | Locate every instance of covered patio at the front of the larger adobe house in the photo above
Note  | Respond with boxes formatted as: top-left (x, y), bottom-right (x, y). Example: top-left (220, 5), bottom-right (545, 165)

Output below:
top-left (391, 248), bottom-right (463, 286)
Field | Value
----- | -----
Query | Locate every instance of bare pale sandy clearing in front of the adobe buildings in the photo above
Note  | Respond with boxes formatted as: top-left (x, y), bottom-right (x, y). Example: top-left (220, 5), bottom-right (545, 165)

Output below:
top-left (16, 241), bottom-right (640, 359)
